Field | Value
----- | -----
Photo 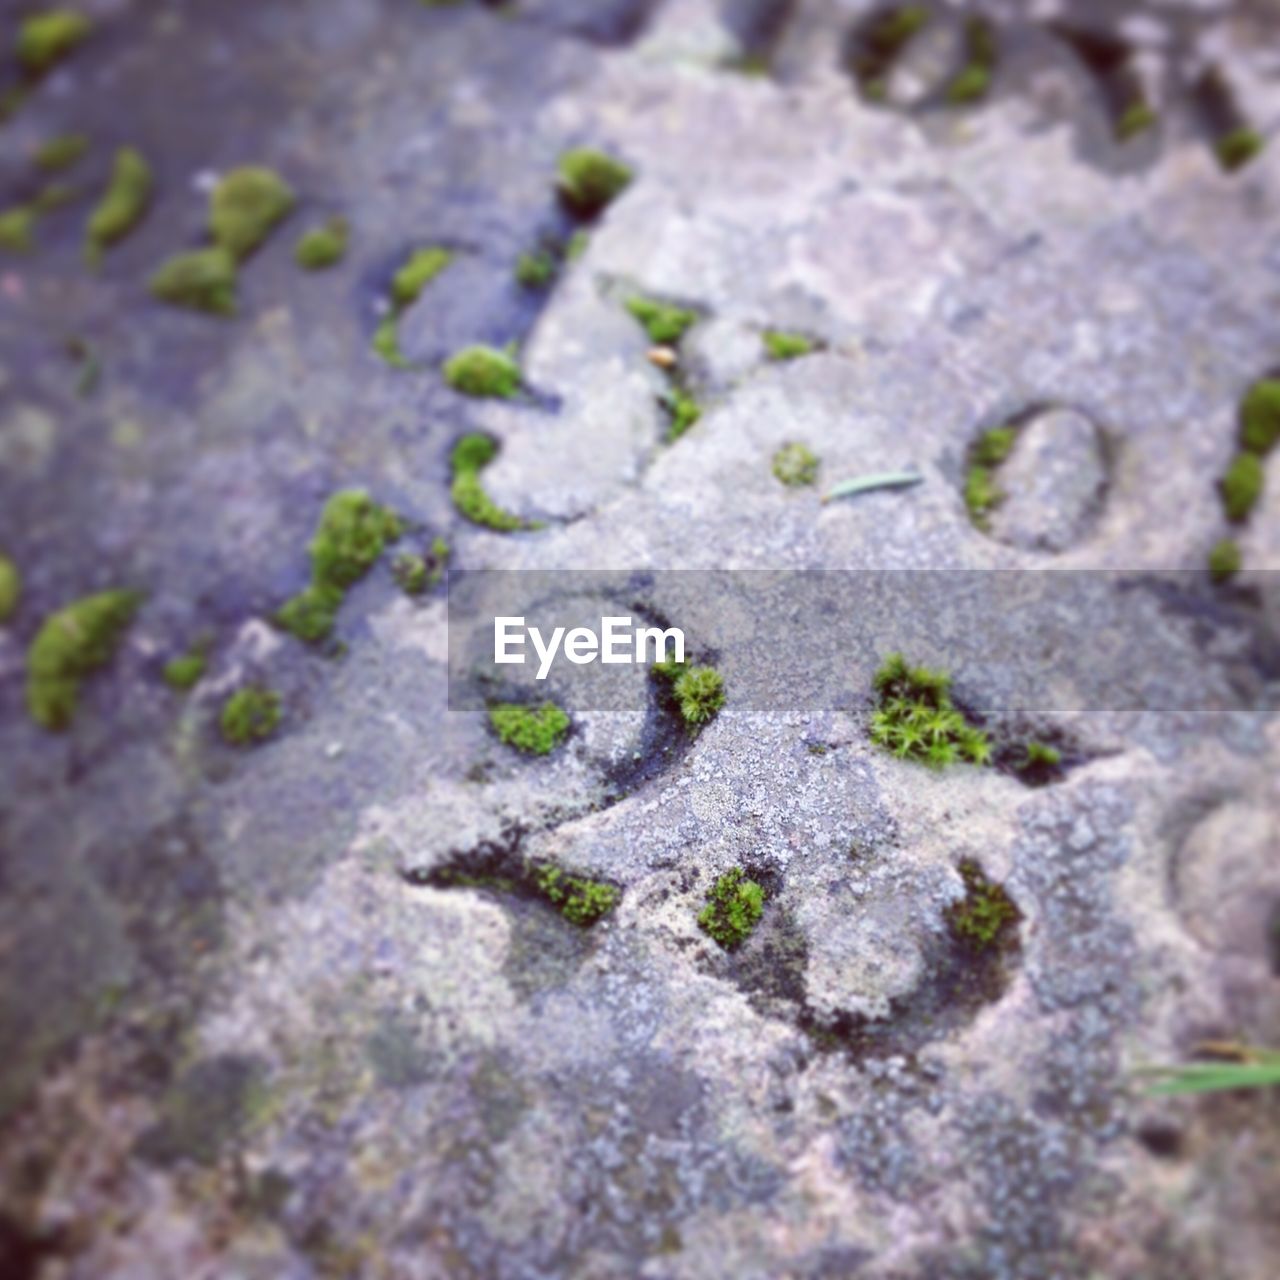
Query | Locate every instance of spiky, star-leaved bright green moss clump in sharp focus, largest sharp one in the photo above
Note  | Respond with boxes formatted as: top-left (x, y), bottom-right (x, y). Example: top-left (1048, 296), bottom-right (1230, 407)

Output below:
top-left (870, 653), bottom-right (991, 769)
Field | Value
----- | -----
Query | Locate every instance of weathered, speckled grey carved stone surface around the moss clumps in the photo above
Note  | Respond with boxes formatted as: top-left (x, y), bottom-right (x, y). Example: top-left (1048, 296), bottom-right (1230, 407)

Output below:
top-left (0, 0), bottom-right (1280, 1280)
